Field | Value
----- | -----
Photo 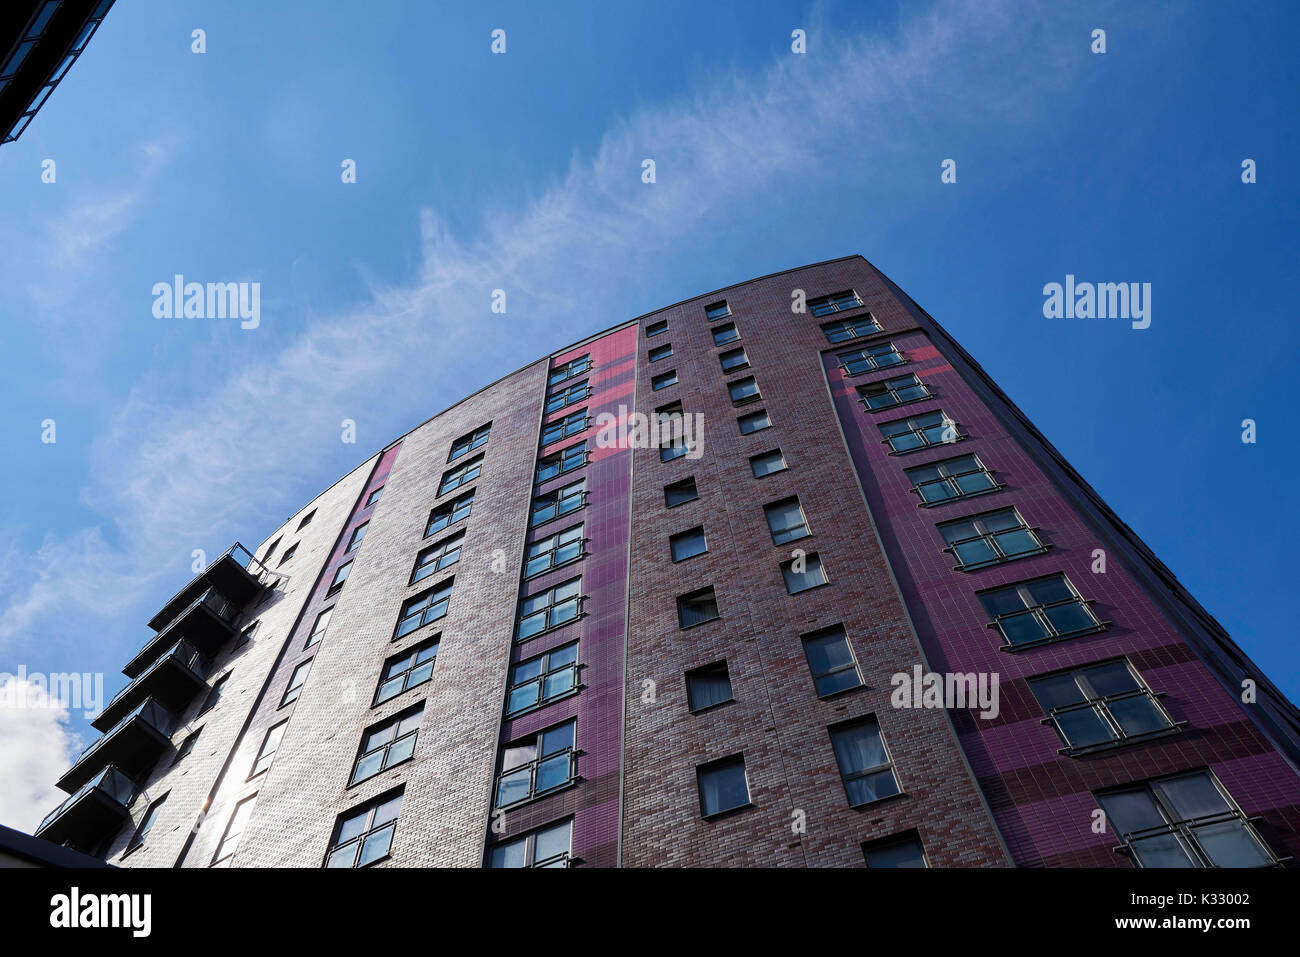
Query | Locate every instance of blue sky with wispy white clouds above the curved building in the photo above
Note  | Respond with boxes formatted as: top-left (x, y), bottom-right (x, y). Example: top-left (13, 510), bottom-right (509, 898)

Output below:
top-left (0, 0), bottom-right (1300, 828)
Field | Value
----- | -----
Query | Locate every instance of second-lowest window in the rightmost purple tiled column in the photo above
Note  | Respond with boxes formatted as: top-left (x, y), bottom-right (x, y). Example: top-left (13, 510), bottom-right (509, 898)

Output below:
top-left (1030, 659), bottom-right (1178, 754)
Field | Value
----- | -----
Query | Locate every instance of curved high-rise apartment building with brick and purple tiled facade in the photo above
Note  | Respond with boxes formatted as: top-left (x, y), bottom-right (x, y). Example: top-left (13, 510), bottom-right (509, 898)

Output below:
top-left (39, 256), bottom-right (1300, 867)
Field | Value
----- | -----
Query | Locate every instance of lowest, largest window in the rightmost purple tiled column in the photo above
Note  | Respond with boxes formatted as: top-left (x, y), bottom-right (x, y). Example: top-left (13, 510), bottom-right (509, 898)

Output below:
top-left (1097, 771), bottom-right (1278, 867)
